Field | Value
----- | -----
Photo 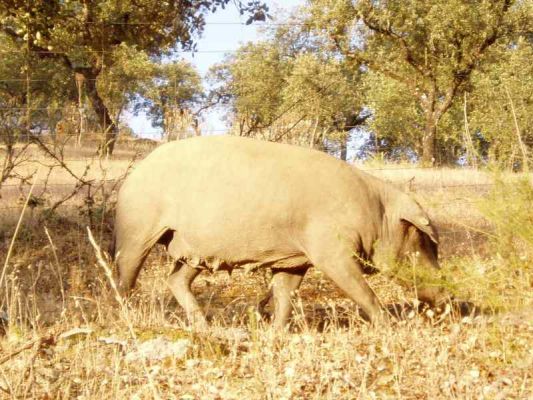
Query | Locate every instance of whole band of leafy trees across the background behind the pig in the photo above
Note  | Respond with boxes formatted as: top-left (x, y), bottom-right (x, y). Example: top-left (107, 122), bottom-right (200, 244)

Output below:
top-left (0, 0), bottom-right (533, 168)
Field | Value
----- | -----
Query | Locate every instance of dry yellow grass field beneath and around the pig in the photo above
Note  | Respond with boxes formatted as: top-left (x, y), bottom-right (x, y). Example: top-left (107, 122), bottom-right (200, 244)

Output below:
top-left (0, 148), bottom-right (533, 400)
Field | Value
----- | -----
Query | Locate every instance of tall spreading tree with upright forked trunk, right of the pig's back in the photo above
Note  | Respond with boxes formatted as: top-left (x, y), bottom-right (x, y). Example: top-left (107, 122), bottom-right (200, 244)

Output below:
top-left (309, 0), bottom-right (521, 164)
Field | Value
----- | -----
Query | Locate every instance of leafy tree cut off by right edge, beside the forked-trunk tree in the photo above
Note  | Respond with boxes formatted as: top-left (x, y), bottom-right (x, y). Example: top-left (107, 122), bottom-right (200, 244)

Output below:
top-left (466, 35), bottom-right (533, 169)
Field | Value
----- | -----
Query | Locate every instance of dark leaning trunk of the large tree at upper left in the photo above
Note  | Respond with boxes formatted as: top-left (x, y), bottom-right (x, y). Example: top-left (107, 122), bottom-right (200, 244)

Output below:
top-left (80, 68), bottom-right (118, 155)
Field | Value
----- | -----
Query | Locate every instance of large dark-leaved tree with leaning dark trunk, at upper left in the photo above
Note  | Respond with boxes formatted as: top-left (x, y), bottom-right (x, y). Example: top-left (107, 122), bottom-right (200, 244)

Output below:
top-left (0, 0), bottom-right (268, 153)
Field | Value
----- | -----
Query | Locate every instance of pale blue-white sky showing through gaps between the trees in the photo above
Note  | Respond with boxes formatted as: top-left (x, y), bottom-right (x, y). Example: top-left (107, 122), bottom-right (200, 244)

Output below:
top-left (126, 0), bottom-right (305, 139)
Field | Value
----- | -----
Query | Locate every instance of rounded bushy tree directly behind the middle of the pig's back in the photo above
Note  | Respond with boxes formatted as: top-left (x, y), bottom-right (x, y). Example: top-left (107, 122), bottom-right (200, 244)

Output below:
top-left (211, 18), bottom-right (366, 159)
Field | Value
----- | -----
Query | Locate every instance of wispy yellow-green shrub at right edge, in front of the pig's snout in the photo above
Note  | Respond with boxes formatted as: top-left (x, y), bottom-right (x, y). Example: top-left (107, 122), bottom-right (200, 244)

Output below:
top-left (432, 178), bottom-right (533, 311)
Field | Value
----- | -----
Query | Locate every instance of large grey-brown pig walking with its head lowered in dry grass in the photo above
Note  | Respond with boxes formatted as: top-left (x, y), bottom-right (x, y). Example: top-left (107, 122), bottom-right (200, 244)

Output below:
top-left (115, 136), bottom-right (444, 328)
